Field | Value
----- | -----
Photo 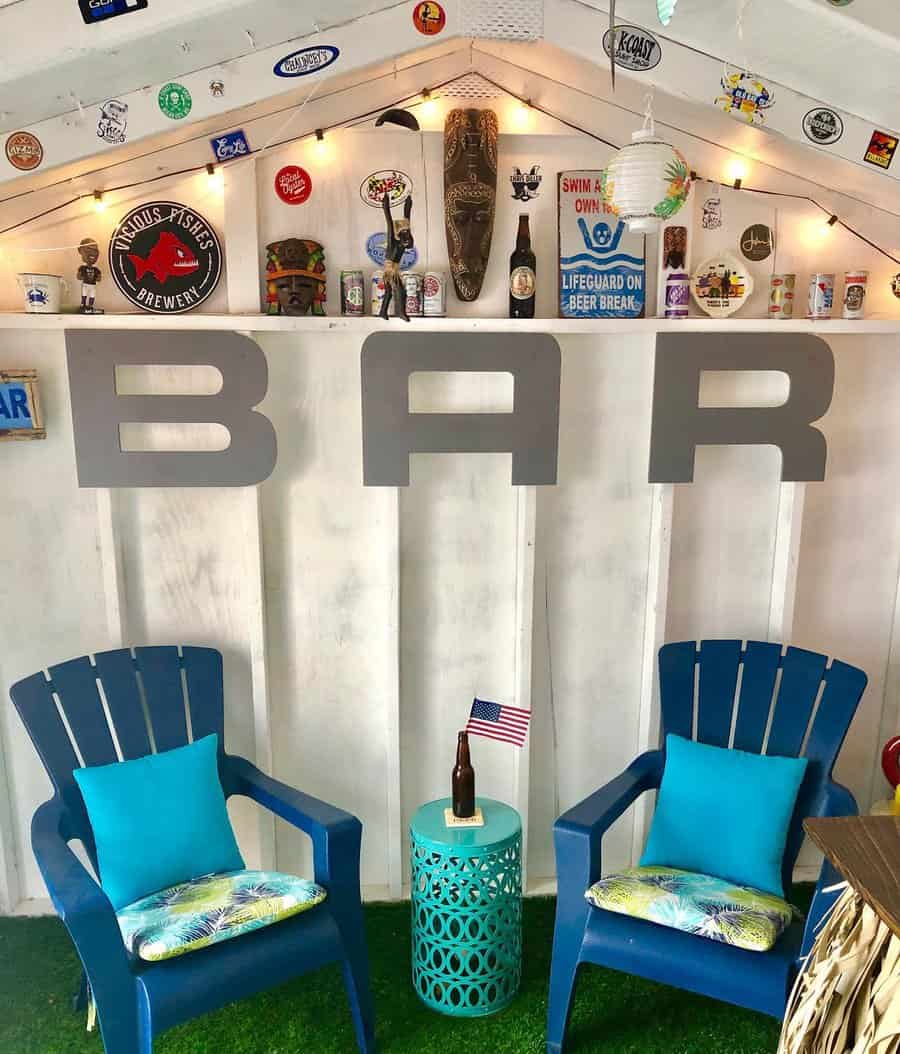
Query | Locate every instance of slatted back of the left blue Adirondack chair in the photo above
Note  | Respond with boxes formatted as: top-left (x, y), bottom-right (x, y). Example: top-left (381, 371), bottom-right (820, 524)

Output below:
top-left (9, 646), bottom-right (224, 847)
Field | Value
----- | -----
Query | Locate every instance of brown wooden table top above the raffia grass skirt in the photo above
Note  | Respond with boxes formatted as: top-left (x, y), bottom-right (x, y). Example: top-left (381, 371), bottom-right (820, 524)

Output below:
top-left (803, 816), bottom-right (900, 936)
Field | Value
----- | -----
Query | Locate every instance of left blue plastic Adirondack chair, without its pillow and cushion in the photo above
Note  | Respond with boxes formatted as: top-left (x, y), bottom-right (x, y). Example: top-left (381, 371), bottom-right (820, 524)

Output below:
top-left (11, 647), bottom-right (375, 1054)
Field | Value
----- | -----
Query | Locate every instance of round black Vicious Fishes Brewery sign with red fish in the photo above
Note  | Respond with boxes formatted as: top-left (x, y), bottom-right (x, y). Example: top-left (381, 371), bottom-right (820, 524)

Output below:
top-left (110, 201), bottom-right (222, 315)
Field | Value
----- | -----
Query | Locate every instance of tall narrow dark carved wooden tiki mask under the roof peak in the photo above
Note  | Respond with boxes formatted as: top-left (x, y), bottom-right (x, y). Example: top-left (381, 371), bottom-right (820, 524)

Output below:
top-left (444, 110), bottom-right (497, 300)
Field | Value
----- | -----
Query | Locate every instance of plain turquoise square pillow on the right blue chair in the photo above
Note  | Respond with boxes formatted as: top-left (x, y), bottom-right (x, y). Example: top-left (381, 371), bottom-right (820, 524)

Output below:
top-left (641, 736), bottom-right (806, 897)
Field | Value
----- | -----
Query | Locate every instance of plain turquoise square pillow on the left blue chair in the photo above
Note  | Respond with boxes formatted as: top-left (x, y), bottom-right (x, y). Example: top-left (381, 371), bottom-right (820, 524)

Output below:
top-left (74, 736), bottom-right (244, 911)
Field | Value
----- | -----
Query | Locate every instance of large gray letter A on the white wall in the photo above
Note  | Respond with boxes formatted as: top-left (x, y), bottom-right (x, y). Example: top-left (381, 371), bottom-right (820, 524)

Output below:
top-left (361, 331), bottom-right (561, 487)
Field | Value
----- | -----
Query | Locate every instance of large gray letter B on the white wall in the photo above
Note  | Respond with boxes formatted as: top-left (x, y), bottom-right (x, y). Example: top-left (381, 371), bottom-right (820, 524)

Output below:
top-left (65, 330), bottom-right (277, 487)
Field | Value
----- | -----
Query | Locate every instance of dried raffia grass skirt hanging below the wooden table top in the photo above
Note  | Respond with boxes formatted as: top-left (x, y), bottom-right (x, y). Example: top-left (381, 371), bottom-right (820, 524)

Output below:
top-left (778, 886), bottom-right (900, 1054)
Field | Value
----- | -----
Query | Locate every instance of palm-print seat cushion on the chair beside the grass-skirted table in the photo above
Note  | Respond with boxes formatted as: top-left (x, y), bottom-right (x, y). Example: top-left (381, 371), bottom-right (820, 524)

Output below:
top-left (585, 867), bottom-right (794, 952)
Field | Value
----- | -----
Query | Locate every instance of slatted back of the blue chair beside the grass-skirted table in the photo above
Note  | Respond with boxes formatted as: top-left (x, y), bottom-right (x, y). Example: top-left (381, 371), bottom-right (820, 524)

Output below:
top-left (660, 641), bottom-right (868, 889)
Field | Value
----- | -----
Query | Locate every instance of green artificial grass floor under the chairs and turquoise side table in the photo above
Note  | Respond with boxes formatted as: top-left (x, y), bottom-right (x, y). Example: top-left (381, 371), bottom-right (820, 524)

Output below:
top-left (0, 891), bottom-right (808, 1054)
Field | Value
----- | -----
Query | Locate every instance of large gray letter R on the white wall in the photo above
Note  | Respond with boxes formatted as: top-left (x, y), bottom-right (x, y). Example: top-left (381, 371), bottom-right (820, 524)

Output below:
top-left (649, 333), bottom-right (835, 483)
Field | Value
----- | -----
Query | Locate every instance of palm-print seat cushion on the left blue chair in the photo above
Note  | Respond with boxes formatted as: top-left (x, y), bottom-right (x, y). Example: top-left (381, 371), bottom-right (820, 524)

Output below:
top-left (116, 871), bottom-right (326, 962)
